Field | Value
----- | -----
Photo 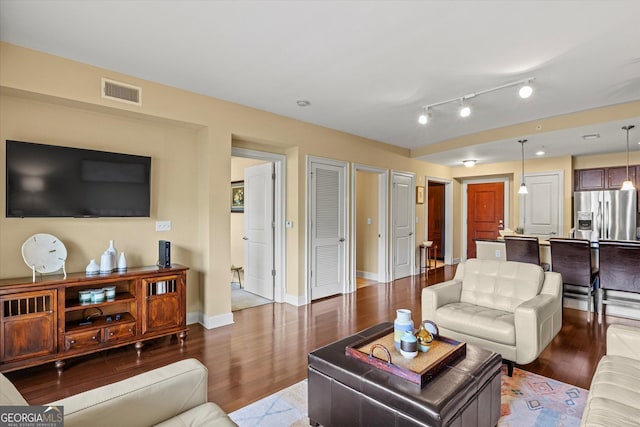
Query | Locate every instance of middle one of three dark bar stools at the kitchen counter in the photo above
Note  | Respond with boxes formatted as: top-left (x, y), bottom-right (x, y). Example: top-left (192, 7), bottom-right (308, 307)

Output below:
top-left (549, 238), bottom-right (598, 313)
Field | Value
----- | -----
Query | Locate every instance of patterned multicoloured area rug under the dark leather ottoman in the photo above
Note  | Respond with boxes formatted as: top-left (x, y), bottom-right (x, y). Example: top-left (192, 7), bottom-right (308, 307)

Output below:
top-left (229, 367), bottom-right (588, 427)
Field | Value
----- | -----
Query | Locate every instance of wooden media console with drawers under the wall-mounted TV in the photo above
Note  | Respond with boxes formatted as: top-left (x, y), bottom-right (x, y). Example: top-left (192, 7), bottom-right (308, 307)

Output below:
top-left (0, 265), bottom-right (187, 372)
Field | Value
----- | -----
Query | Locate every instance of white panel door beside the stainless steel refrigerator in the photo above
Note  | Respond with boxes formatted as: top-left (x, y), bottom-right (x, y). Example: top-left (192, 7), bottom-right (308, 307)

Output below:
top-left (521, 172), bottom-right (563, 239)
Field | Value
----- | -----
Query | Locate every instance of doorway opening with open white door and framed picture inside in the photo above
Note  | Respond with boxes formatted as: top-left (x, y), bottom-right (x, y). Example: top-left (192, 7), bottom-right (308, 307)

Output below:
top-left (229, 148), bottom-right (285, 311)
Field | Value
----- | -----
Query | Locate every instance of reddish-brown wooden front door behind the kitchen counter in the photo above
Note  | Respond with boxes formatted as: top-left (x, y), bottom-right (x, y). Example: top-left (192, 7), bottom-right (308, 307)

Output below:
top-left (467, 182), bottom-right (504, 259)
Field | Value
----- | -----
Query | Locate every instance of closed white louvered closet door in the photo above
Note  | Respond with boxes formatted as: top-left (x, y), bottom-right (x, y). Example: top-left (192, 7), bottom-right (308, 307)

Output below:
top-left (310, 161), bottom-right (346, 300)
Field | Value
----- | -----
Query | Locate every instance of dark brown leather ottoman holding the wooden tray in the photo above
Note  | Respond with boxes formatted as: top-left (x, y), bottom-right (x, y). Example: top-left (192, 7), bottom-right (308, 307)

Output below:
top-left (308, 322), bottom-right (502, 427)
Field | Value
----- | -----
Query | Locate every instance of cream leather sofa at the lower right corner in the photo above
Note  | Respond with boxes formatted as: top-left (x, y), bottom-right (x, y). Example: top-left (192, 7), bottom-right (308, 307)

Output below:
top-left (580, 325), bottom-right (640, 426)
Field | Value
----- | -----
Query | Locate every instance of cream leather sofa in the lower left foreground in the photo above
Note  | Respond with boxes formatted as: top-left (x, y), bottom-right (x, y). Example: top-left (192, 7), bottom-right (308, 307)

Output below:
top-left (0, 359), bottom-right (236, 427)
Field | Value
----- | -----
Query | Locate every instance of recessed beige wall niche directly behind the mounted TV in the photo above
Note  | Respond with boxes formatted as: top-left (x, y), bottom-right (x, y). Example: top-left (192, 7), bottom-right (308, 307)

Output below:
top-left (0, 96), bottom-right (202, 311)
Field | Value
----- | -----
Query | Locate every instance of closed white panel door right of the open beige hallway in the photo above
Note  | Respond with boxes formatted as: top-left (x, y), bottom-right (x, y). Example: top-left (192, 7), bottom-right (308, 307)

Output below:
top-left (391, 172), bottom-right (415, 280)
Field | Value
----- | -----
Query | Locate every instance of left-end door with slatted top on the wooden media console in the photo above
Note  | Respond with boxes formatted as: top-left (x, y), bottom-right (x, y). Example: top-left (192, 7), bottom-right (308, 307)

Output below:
top-left (0, 290), bottom-right (57, 362)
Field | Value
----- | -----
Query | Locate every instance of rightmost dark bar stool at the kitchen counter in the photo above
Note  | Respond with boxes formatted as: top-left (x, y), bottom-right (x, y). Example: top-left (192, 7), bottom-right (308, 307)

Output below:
top-left (598, 240), bottom-right (640, 315)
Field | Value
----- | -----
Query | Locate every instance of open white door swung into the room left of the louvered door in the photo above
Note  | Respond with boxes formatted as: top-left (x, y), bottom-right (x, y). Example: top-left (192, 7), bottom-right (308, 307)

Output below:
top-left (243, 163), bottom-right (274, 300)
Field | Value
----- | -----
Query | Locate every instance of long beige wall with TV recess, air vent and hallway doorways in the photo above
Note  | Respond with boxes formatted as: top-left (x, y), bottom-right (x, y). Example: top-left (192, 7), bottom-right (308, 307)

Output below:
top-left (0, 43), bottom-right (450, 325)
